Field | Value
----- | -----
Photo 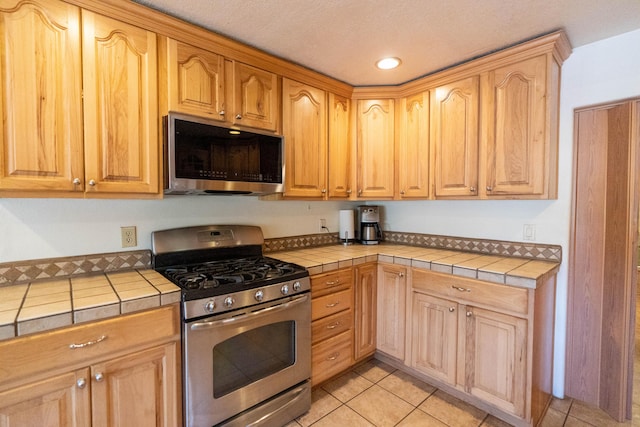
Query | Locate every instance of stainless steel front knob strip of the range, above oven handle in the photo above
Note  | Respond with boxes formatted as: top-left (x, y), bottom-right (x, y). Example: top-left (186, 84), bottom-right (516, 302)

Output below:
top-left (183, 277), bottom-right (311, 319)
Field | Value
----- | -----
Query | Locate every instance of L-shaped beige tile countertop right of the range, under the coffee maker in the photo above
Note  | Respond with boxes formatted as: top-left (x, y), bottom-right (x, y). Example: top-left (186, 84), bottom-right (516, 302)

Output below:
top-left (267, 244), bottom-right (560, 289)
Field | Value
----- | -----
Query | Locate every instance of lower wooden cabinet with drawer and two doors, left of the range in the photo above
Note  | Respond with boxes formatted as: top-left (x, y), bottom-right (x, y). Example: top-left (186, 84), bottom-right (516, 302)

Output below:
top-left (0, 305), bottom-right (181, 427)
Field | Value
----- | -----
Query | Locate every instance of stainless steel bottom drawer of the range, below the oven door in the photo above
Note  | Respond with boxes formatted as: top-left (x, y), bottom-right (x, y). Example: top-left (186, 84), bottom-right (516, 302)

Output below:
top-left (219, 381), bottom-right (311, 427)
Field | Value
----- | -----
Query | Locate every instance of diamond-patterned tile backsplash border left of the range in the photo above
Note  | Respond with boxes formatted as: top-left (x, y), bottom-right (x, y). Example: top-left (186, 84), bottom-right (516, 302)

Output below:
top-left (0, 250), bottom-right (151, 286)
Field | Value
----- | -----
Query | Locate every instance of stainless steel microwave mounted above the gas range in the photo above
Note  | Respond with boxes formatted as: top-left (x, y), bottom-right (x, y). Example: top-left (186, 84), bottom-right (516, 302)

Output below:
top-left (164, 113), bottom-right (284, 195)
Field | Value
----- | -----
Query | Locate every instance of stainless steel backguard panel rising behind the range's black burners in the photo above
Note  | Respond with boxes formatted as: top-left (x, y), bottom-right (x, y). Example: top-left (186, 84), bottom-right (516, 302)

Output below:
top-left (151, 225), bottom-right (264, 255)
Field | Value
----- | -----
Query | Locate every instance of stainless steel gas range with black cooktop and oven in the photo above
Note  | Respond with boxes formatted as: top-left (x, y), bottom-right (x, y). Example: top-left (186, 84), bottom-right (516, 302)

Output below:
top-left (151, 225), bottom-right (311, 427)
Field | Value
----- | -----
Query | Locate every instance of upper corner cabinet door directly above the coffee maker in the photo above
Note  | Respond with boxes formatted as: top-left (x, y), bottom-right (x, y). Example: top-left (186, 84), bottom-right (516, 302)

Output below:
top-left (356, 99), bottom-right (395, 199)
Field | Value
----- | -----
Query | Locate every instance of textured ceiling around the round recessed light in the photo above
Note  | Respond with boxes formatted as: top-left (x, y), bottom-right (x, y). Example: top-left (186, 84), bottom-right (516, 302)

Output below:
top-left (135, 0), bottom-right (640, 86)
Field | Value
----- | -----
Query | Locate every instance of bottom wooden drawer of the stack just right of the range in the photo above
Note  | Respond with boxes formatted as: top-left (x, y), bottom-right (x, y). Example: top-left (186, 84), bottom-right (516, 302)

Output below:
top-left (311, 331), bottom-right (353, 385)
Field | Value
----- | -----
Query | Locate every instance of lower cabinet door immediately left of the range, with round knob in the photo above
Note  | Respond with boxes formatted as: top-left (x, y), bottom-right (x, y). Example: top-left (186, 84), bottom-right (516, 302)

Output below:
top-left (91, 343), bottom-right (180, 427)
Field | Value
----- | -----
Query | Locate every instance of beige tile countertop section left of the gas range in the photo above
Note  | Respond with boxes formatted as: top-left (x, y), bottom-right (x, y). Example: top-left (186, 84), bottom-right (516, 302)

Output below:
top-left (0, 269), bottom-right (180, 340)
